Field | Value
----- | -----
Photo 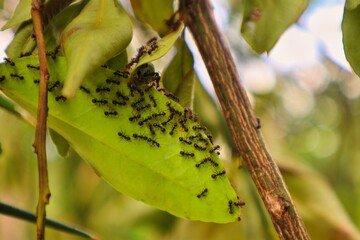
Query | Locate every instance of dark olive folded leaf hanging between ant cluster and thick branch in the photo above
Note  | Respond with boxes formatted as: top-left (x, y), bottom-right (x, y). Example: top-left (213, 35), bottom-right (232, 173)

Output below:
top-left (163, 38), bottom-right (195, 107)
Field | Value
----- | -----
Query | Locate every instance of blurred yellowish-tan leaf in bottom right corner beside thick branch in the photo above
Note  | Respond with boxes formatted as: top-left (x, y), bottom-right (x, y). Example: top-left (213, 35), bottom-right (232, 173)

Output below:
top-left (279, 159), bottom-right (360, 240)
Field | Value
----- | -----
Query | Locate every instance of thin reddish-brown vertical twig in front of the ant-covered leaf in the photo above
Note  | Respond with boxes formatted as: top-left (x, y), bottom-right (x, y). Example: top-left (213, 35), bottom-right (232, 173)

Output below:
top-left (31, 0), bottom-right (51, 240)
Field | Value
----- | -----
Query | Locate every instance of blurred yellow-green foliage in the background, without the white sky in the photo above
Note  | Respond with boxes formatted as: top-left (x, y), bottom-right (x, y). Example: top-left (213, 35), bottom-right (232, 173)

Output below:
top-left (0, 1), bottom-right (360, 240)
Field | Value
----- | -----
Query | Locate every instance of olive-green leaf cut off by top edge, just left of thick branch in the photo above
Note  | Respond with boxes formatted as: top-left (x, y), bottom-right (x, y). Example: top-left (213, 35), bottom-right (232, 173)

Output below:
top-left (131, 0), bottom-right (173, 36)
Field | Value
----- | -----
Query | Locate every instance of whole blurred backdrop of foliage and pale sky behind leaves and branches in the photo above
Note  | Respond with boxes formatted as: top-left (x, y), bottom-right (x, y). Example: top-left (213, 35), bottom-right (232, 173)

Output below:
top-left (0, 0), bottom-right (360, 240)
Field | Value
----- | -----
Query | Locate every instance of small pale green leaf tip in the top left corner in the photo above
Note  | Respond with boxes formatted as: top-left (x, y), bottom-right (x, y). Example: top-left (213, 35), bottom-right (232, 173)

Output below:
top-left (1, 0), bottom-right (31, 30)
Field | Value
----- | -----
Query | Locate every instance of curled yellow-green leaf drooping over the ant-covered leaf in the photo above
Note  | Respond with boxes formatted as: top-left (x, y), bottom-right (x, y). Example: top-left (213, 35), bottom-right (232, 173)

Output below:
top-left (61, 0), bottom-right (132, 98)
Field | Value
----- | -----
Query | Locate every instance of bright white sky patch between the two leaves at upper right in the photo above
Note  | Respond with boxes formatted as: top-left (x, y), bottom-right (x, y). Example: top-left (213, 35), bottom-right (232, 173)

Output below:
top-left (269, 2), bottom-right (350, 71)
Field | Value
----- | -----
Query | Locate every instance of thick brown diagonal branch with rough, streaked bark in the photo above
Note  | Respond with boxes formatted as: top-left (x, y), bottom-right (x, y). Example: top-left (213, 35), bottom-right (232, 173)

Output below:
top-left (180, 0), bottom-right (310, 240)
